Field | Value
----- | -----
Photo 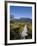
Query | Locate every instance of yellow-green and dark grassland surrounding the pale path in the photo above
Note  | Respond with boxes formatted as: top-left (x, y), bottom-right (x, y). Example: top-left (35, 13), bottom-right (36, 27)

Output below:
top-left (10, 22), bottom-right (32, 40)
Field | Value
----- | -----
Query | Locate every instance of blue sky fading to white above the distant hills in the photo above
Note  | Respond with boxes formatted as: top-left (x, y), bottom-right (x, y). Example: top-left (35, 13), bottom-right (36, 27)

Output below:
top-left (10, 6), bottom-right (32, 19)
